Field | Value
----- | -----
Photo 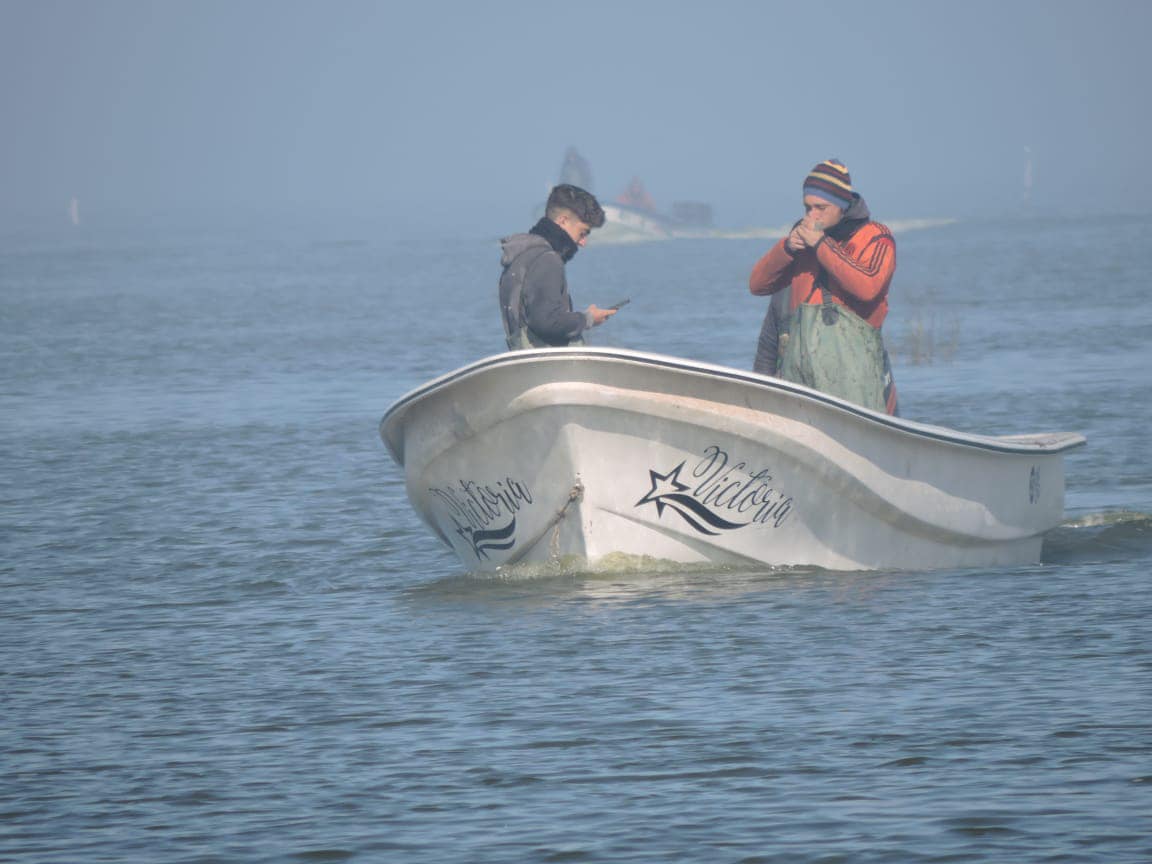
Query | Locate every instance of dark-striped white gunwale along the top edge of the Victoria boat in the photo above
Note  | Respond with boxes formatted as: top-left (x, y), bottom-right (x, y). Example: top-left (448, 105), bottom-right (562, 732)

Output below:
top-left (380, 346), bottom-right (1086, 464)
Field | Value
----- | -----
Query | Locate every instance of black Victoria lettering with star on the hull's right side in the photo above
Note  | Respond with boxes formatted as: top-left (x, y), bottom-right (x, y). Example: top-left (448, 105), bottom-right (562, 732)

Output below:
top-left (636, 445), bottom-right (793, 535)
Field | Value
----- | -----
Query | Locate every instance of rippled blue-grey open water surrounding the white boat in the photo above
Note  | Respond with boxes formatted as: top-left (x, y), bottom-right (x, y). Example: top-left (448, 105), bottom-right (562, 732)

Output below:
top-left (0, 211), bottom-right (1152, 864)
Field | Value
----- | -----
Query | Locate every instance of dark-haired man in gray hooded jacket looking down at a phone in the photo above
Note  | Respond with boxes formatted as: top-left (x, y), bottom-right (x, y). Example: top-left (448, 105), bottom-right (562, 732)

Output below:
top-left (500, 183), bottom-right (616, 351)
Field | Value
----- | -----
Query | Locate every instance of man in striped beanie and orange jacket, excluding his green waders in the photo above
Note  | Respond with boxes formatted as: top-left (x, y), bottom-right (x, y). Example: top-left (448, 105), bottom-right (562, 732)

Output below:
top-left (749, 159), bottom-right (896, 414)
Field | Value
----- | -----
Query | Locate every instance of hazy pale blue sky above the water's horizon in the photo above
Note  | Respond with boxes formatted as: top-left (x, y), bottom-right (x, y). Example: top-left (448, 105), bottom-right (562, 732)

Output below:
top-left (0, 0), bottom-right (1152, 233)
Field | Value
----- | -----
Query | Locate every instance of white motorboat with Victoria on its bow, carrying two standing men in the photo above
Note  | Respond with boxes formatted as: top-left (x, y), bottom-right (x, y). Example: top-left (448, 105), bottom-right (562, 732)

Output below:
top-left (380, 347), bottom-right (1085, 571)
